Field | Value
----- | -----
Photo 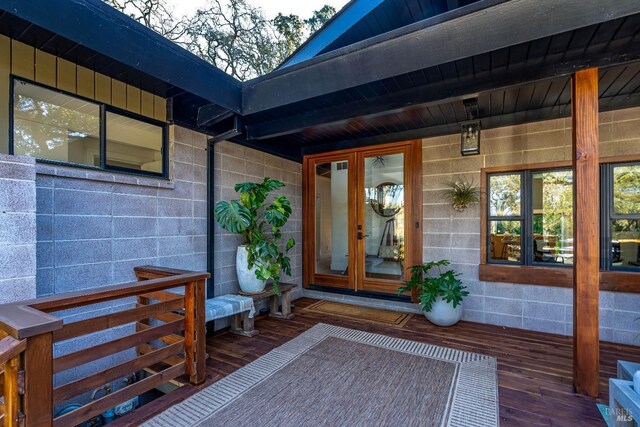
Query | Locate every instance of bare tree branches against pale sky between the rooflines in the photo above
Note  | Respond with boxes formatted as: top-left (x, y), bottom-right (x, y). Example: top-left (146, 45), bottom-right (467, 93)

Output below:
top-left (104, 0), bottom-right (335, 80)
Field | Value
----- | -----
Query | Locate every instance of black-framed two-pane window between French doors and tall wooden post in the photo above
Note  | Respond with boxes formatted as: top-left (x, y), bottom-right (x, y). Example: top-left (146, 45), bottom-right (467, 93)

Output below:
top-left (486, 169), bottom-right (573, 266)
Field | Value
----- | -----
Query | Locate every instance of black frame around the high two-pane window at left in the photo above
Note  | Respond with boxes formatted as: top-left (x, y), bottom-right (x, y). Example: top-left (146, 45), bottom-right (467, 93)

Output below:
top-left (9, 74), bottom-right (169, 179)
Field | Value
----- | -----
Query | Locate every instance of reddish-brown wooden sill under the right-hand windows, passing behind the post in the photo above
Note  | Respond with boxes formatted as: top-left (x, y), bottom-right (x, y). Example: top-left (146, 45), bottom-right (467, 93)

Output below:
top-left (479, 264), bottom-right (640, 293)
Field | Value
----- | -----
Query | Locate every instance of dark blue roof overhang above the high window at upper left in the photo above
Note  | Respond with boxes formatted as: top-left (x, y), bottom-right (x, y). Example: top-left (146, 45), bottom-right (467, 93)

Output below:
top-left (0, 0), bottom-right (242, 117)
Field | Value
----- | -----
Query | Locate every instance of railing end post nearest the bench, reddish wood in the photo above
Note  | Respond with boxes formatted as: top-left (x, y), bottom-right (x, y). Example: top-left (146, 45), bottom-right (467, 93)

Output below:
top-left (184, 280), bottom-right (206, 385)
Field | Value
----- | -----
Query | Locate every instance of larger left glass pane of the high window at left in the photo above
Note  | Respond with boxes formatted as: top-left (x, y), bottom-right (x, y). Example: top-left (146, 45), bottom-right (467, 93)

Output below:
top-left (13, 80), bottom-right (100, 166)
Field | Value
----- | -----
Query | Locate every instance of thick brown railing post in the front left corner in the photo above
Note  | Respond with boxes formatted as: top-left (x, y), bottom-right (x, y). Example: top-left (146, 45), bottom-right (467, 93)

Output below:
top-left (24, 332), bottom-right (53, 426)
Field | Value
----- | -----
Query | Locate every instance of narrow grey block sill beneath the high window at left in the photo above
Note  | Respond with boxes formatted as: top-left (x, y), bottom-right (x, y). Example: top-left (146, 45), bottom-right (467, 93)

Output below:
top-left (36, 163), bottom-right (175, 189)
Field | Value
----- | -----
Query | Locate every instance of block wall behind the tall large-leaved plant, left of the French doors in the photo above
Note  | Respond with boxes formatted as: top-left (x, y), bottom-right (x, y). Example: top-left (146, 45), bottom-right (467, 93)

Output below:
top-left (213, 142), bottom-right (302, 298)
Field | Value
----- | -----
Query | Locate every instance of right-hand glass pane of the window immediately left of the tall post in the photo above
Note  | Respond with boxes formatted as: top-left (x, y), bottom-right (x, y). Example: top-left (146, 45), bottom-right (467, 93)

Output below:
top-left (533, 171), bottom-right (573, 264)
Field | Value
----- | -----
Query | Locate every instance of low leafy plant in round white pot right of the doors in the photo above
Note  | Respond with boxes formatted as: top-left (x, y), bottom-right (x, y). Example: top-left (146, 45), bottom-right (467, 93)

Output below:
top-left (398, 260), bottom-right (469, 326)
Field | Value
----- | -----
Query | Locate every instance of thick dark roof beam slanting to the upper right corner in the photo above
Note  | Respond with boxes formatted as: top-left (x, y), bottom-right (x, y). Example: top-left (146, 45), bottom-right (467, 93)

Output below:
top-left (243, 0), bottom-right (640, 115)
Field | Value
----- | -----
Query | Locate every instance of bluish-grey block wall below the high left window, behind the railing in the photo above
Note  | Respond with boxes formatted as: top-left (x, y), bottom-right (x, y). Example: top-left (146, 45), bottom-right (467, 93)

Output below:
top-left (36, 127), bottom-right (207, 296)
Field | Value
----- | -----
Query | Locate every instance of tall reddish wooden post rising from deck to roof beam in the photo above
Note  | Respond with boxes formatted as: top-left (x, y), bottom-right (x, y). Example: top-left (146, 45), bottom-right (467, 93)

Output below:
top-left (571, 68), bottom-right (600, 397)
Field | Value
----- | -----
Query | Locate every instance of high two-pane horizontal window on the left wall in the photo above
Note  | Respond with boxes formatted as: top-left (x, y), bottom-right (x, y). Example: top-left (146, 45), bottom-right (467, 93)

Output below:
top-left (12, 79), bottom-right (166, 176)
